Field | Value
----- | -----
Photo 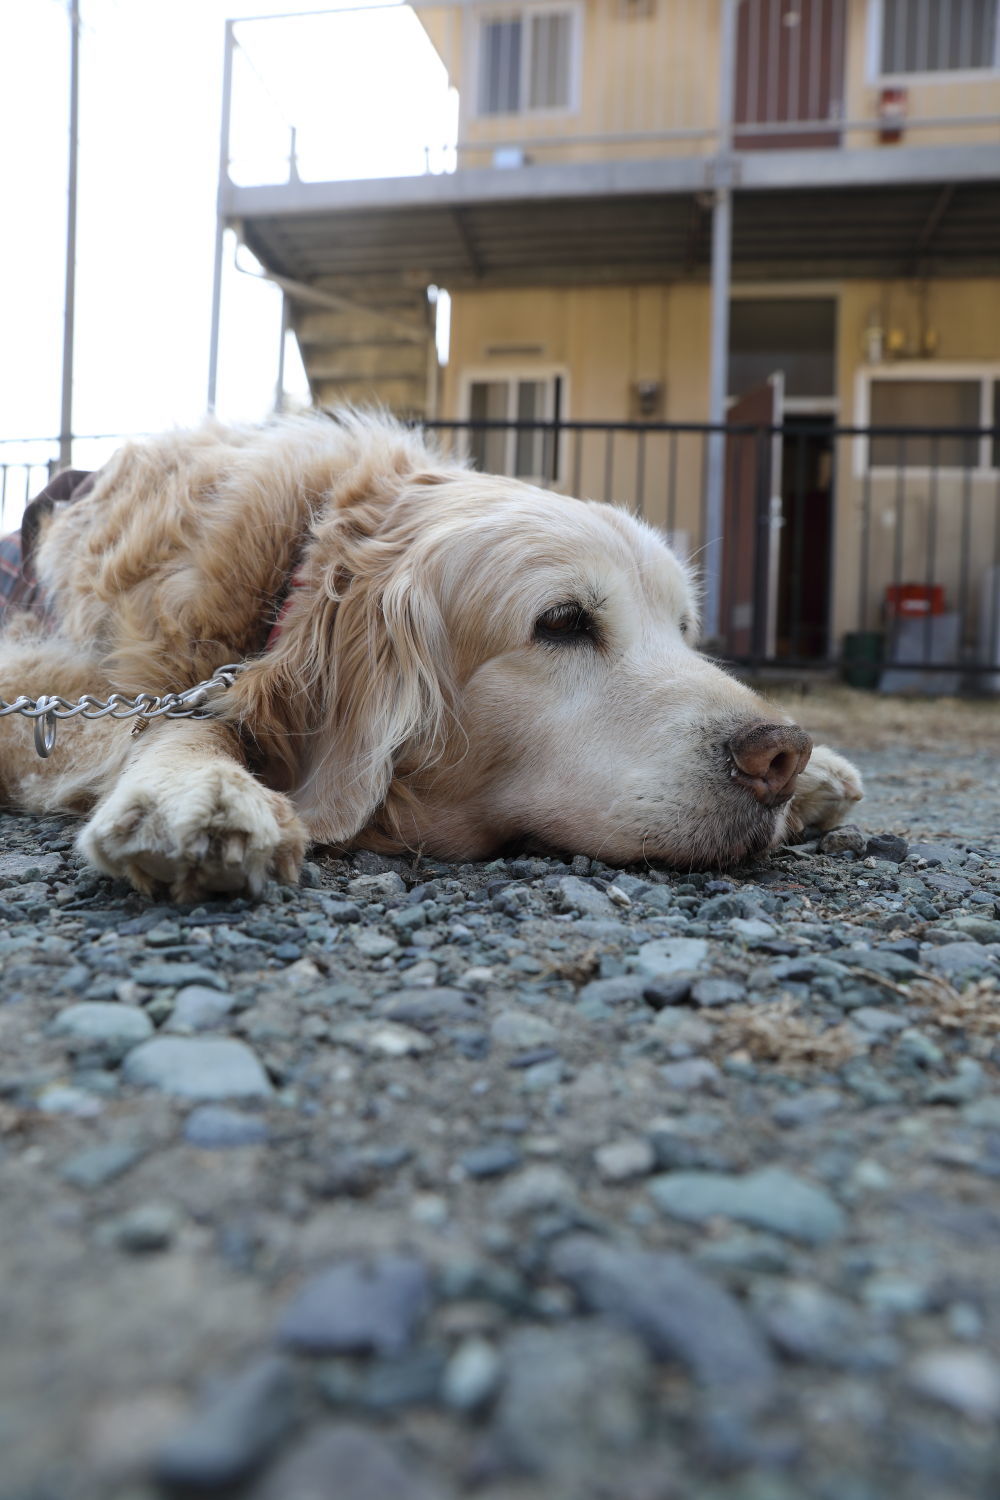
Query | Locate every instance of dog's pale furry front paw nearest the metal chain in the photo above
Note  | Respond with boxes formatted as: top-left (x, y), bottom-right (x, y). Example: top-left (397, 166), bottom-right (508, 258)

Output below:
top-left (78, 761), bottom-right (307, 902)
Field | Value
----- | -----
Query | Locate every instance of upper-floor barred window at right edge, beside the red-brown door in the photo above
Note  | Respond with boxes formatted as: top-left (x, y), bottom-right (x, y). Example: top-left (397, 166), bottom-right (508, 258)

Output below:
top-left (882, 0), bottom-right (1000, 74)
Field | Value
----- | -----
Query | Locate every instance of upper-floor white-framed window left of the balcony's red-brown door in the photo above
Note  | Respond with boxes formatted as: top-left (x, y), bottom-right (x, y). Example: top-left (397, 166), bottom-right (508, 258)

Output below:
top-left (478, 8), bottom-right (573, 114)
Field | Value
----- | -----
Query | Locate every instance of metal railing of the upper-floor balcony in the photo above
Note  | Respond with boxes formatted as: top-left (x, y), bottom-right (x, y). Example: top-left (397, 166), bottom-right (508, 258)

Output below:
top-left (223, 0), bottom-right (1000, 185)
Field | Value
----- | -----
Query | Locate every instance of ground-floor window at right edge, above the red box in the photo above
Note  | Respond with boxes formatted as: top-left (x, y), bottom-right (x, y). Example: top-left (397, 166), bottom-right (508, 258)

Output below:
top-left (861, 366), bottom-right (1000, 471)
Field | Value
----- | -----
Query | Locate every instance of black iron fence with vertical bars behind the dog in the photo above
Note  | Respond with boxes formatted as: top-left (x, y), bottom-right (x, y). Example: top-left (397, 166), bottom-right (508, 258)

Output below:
top-left (7, 414), bottom-right (1000, 695)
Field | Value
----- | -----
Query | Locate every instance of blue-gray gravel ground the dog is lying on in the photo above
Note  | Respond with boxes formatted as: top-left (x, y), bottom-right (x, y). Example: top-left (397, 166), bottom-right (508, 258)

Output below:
top-left (0, 699), bottom-right (1000, 1500)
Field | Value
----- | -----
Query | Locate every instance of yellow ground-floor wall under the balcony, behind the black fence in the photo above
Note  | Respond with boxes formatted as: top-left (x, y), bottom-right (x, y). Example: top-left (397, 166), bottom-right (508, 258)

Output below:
top-left (442, 279), bottom-right (1000, 639)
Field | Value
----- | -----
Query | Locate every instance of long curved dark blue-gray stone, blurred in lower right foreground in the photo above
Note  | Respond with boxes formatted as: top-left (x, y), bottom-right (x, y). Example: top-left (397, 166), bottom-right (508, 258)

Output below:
top-left (550, 1235), bottom-right (775, 1410)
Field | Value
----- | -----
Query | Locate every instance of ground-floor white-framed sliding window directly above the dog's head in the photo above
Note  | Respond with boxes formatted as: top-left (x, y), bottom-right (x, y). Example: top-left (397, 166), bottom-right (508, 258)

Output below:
top-left (468, 375), bottom-right (565, 483)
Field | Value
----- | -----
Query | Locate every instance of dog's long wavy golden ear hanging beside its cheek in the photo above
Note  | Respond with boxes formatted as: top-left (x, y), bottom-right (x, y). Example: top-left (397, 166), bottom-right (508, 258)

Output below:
top-left (222, 512), bottom-right (451, 845)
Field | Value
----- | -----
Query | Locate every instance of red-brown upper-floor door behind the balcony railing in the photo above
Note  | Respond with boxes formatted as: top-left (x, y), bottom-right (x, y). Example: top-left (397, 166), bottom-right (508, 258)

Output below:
top-left (735, 0), bottom-right (847, 152)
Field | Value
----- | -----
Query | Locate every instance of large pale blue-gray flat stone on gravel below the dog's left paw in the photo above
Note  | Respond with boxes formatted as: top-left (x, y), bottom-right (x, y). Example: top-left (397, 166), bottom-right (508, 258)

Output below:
top-left (123, 1037), bottom-right (273, 1100)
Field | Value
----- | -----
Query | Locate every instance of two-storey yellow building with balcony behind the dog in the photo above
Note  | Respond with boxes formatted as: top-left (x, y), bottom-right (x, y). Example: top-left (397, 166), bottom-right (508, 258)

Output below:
top-left (212, 0), bottom-right (1000, 675)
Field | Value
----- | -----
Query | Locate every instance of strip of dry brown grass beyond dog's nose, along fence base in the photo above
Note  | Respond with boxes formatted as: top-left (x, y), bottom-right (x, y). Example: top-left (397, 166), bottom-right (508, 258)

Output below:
top-left (765, 684), bottom-right (1000, 753)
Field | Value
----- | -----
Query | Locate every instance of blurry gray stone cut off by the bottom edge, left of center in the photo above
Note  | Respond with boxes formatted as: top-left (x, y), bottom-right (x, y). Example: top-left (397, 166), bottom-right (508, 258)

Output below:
top-left (249, 1422), bottom-right (437, 1500)
